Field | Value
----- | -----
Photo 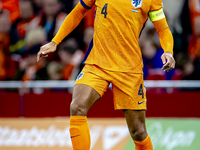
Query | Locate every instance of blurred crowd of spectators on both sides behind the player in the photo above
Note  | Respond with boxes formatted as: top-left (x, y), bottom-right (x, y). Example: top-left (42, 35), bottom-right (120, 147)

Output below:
top-left (0, 0), bottom-right (200, 81)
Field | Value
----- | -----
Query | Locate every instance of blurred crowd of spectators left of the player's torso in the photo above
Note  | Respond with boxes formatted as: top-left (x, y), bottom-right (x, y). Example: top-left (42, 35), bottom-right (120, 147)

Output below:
top-left (0, 0), bottom-right (95, 81)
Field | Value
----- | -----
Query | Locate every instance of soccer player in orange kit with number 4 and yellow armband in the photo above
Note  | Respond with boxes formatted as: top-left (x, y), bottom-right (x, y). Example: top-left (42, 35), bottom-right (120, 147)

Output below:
top-left (37, 0), bottom-right (175, 150)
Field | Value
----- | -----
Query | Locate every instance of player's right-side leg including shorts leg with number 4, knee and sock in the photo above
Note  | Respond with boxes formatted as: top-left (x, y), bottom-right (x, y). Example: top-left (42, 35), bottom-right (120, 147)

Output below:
top-left (112, 72), bottom-right (153, 150)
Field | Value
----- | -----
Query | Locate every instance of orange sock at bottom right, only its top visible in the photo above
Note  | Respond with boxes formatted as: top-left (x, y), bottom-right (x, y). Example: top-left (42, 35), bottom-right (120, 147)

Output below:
top-left (134, 135), bottom-right (153, 150)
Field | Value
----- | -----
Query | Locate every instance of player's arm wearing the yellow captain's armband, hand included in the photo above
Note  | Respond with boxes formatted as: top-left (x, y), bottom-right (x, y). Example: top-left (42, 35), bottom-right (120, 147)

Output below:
top-left (149, 8), bottom-right (175, 71)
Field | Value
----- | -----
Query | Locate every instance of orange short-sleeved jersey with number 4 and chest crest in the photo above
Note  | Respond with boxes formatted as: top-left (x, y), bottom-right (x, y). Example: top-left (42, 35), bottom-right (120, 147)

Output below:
top-left (81, 0), bottom-right (163, 73)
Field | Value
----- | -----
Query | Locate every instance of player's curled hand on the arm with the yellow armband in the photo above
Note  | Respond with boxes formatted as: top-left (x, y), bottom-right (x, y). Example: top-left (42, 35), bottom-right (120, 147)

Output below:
top-left (161, 52), bottom-right (176, 71)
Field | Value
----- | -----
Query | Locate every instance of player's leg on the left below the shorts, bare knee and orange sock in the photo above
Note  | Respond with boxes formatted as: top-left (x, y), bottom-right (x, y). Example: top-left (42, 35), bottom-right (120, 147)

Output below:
top-left (70, 84), bottom-right (100, 150)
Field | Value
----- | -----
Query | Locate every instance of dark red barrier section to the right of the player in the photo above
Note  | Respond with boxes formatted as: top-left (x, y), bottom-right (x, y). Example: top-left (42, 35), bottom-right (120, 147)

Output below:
top-left (147, 92), bottom-right (200, 117)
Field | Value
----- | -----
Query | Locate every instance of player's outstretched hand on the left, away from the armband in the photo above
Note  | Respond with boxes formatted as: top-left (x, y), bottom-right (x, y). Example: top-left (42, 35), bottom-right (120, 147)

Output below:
top-left (37, 42), bottom-right (57, 62)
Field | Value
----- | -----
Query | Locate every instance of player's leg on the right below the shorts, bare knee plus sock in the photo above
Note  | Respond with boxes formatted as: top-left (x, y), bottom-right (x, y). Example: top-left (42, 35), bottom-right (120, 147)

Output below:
top-left (123, 110), bottom-right (153, 150)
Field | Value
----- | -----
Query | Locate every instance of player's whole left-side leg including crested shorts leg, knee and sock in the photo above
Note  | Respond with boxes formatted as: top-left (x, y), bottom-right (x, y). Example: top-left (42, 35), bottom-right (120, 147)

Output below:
top-left (70, 65), bottom-right (109, 150)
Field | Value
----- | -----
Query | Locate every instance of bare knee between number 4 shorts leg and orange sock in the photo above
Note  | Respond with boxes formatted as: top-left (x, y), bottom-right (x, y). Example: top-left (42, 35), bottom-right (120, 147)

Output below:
top-left (123, 110), bottom-right (147, 141)
